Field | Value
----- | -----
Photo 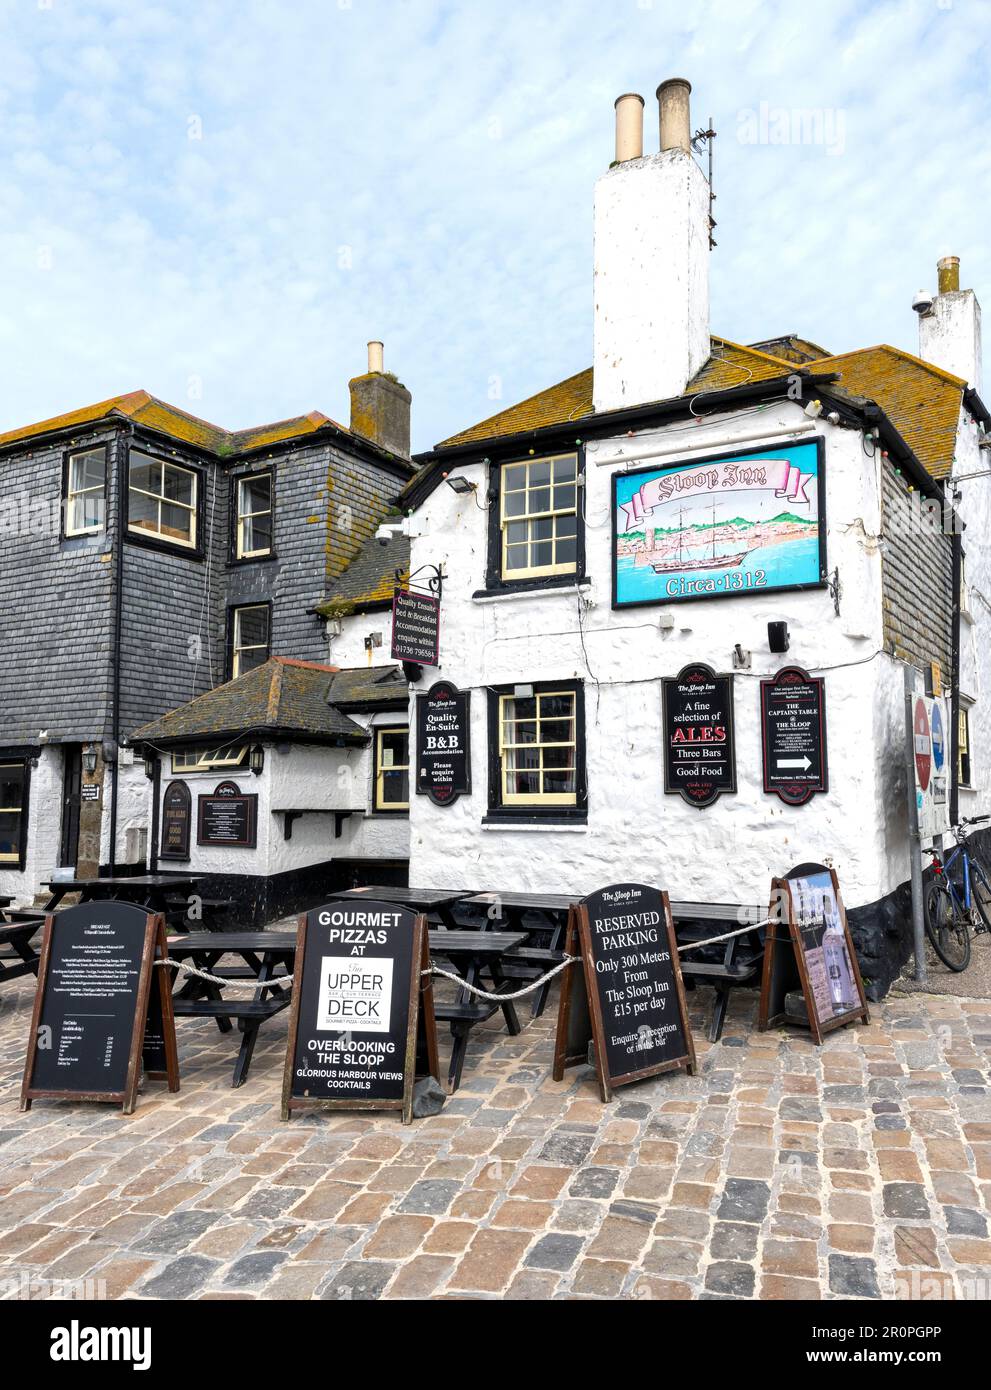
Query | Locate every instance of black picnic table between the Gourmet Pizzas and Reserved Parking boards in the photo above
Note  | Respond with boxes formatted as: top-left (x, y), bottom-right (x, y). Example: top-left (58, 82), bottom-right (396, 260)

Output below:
top-left (429, 930), bottom-right (528, 1091)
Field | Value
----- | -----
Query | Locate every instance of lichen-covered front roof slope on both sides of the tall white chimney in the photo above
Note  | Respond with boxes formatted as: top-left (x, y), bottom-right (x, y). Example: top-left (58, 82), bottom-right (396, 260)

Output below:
top-left (438, 338), bottom-right (795, 449)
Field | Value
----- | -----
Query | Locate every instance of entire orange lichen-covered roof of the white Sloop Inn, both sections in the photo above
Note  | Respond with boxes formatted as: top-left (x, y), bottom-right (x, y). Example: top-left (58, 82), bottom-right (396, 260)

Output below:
top-left (428, 334), bottom-right (966, 480)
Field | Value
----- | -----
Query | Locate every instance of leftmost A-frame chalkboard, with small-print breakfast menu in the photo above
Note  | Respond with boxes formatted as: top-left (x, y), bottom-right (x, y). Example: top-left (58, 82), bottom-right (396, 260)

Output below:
top-left (21, 902), bottom-right (179, 1115)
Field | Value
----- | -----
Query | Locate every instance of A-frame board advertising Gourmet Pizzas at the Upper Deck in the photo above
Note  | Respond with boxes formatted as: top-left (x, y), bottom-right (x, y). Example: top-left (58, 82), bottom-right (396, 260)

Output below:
top-left (282, 898), bottom-right (439, 1125)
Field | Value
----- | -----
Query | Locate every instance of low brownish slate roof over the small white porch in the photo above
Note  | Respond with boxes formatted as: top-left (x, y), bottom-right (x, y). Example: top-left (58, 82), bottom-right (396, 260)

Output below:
top-left (132, 656), bottom-right (368, 746)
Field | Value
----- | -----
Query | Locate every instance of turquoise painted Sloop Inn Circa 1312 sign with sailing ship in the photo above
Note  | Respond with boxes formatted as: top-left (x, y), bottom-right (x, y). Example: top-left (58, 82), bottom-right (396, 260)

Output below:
top-left (613, 441), bottom-right (826, 607)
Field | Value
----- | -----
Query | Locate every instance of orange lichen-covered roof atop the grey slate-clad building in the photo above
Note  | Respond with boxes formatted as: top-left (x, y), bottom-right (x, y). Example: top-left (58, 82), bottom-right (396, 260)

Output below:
top-left (0, 391), bottom-right (413, 473)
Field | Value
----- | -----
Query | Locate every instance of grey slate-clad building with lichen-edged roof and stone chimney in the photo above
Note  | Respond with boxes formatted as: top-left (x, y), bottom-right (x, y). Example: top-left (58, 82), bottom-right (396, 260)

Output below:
top-left (0, 345), bottom-right (413, 901)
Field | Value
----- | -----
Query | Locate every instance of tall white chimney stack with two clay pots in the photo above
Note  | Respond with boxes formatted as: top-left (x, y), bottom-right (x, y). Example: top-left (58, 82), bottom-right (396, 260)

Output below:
top-left (592, 78), bottom-right (709, 410)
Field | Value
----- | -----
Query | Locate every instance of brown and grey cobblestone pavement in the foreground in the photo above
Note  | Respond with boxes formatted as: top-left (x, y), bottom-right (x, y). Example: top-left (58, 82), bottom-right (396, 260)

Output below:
top-left (0, 981), bottom-right (991, 1300)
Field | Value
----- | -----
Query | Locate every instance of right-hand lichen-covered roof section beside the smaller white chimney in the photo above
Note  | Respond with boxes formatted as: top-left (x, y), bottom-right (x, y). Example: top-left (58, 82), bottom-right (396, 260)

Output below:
top-left (816, 343), bottom-right (966, 478)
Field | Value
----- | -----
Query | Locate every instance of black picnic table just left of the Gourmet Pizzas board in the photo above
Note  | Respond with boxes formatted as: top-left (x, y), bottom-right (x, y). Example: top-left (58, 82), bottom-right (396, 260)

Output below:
top-left (168, 931), bottom-right (296, 1087)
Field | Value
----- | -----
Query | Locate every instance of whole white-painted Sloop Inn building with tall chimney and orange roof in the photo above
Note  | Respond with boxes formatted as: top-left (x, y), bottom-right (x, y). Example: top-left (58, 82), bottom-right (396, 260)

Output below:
top-left (331, 81), bottom-right (991, 994)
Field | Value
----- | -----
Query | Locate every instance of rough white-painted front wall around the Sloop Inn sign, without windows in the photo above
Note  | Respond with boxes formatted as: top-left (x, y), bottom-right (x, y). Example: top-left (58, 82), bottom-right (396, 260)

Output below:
top-left (410, 402), bottom-right (956, 906)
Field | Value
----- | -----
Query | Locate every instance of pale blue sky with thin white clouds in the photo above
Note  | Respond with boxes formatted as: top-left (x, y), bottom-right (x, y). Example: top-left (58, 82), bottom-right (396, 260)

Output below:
top-left (0, 0), bottom-right (991, 449)
